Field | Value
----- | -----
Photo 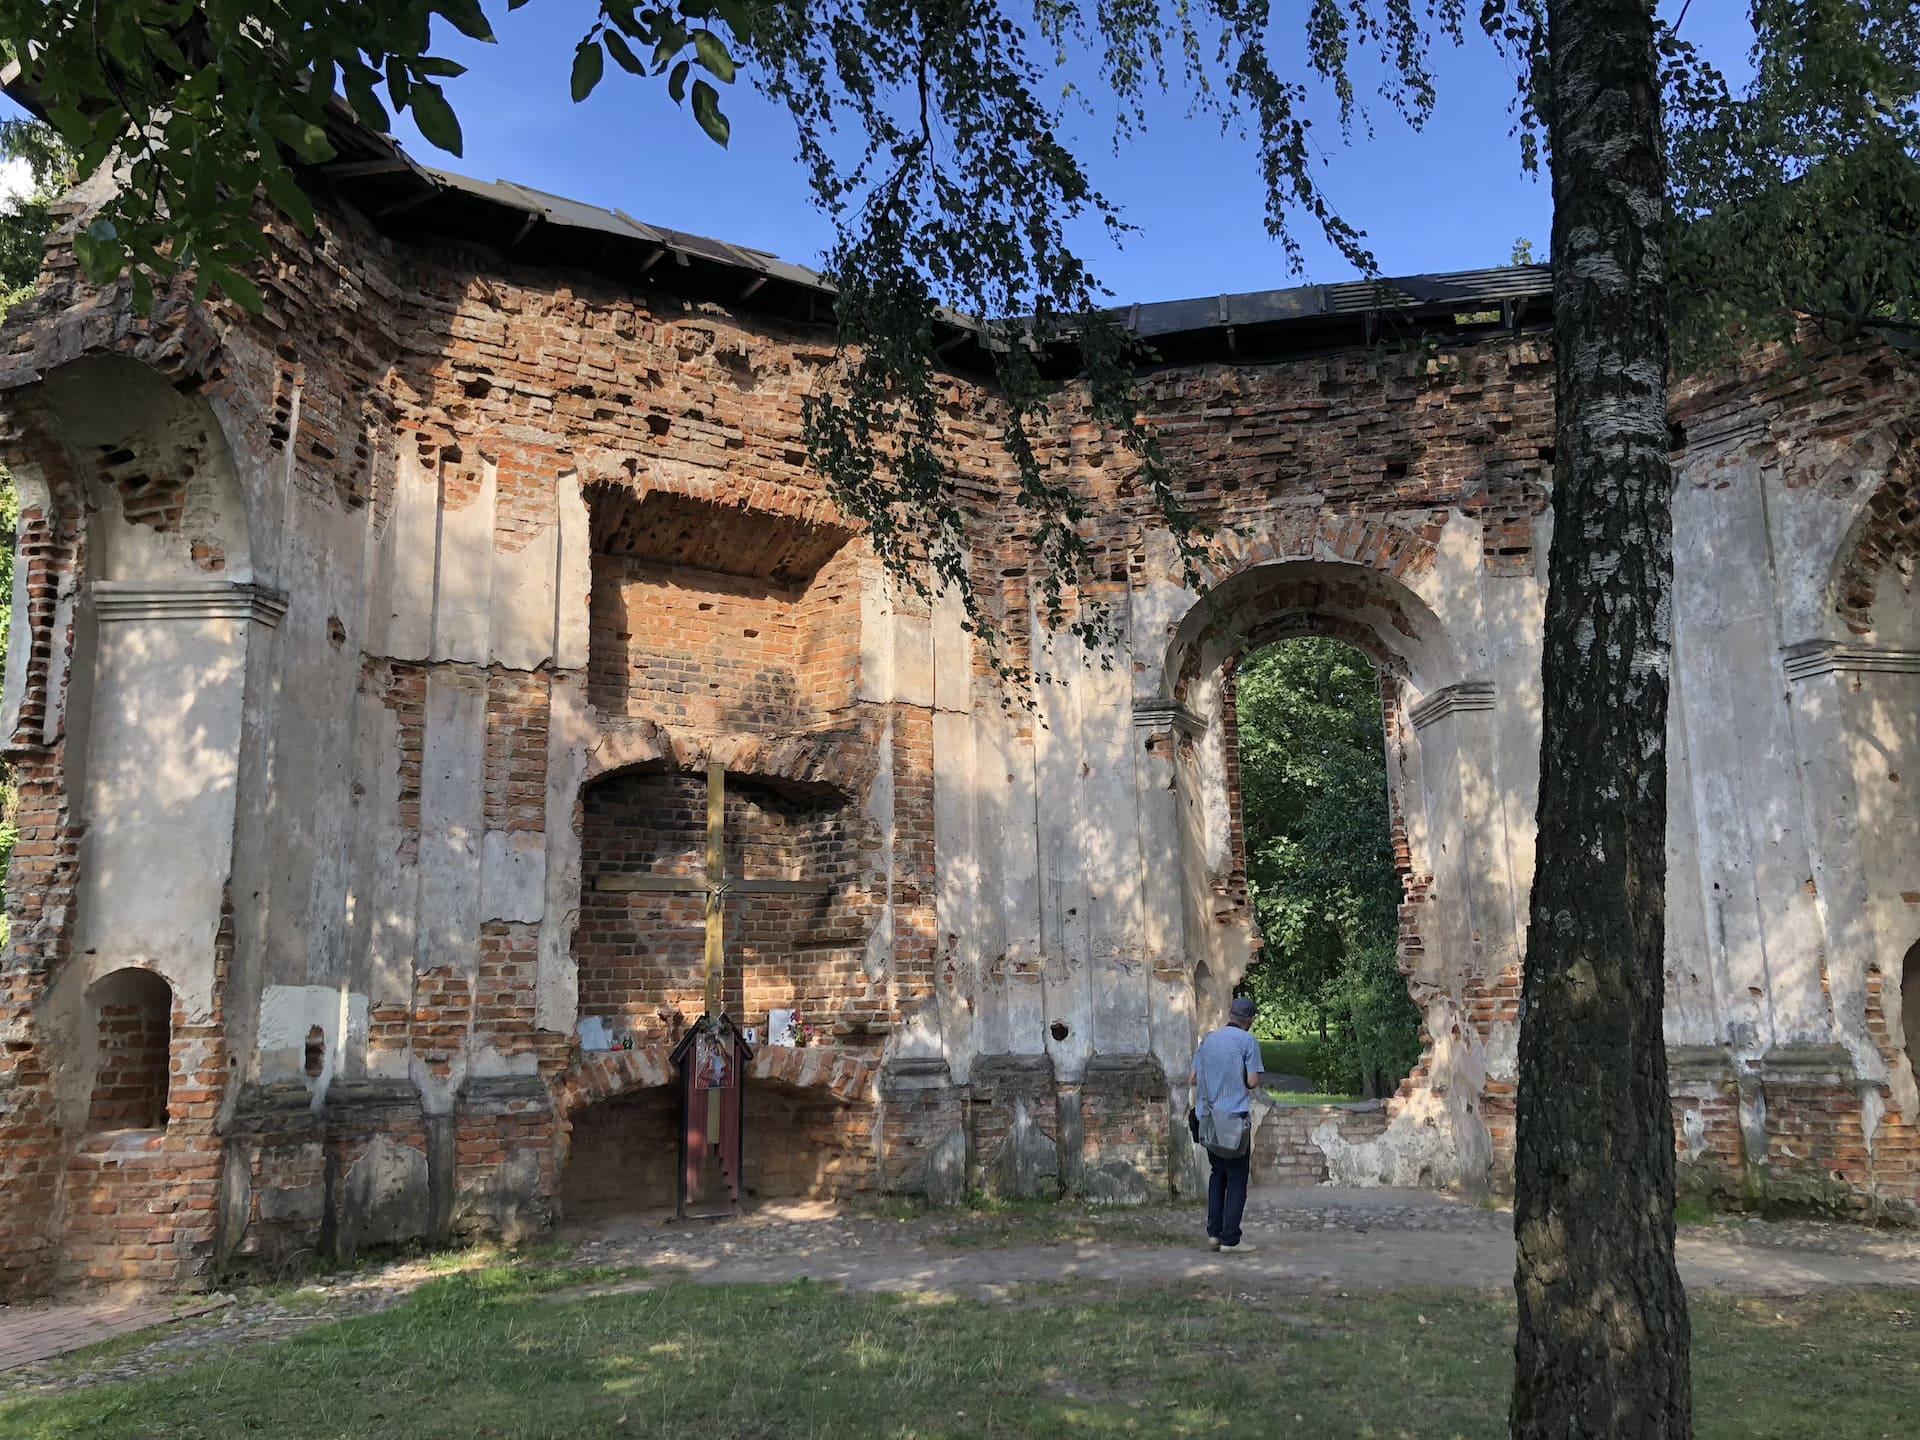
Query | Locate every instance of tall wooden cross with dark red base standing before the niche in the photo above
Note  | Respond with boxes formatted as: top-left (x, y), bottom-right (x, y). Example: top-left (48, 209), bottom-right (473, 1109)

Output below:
top-left (593, 760), bottom-right (831, 1215)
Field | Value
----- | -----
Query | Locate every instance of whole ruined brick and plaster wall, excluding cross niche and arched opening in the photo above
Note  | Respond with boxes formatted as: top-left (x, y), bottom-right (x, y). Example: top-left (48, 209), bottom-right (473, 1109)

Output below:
top-left (0, 168), bottom-right (1920, 1297)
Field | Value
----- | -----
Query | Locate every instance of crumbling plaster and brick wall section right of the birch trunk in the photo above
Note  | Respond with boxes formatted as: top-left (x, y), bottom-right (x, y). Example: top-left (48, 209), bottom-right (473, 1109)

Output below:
top-left (1667, 344), bottom-right (1920, 1213)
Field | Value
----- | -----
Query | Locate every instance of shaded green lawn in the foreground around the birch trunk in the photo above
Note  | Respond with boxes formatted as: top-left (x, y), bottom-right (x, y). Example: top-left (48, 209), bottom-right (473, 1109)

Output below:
top-left (0, 1263), bottom-right (1920, 1440)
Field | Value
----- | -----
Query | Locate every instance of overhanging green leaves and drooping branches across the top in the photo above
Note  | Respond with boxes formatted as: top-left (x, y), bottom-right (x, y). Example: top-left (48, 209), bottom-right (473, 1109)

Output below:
top-left (0, 0), bottom-right (1920, 653)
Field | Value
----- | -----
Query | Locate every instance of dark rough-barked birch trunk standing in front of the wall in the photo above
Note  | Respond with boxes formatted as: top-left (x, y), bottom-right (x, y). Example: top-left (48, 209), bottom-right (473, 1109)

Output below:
top-left (1511, 0), bottom-right (1692, 1440)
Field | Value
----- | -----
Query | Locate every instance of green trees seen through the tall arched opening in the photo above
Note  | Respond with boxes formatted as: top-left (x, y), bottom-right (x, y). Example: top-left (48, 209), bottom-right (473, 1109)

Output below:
top-left (1236, 637), bottom-right (1421, 1096)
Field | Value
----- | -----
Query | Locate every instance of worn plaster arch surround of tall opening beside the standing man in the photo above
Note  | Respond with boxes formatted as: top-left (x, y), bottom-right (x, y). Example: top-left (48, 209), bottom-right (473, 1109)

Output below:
top-left (1162, 545), bottom-right (1512, 1187)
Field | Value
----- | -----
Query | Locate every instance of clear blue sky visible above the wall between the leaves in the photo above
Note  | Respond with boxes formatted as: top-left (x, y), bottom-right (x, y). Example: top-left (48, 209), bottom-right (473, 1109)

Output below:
top-left (7, 0), bottom-right (1751, 301)
